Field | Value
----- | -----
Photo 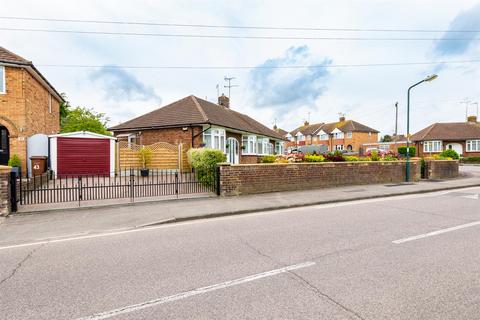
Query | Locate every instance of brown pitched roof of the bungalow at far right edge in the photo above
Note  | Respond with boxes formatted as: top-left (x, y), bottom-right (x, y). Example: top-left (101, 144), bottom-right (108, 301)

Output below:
top-left (411, 122), bottom-right (480, 141)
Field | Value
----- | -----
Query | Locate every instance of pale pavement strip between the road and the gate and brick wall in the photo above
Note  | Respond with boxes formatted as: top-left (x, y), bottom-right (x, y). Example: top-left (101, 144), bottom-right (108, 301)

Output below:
top-left (0, 166), bottom-right (480, 245)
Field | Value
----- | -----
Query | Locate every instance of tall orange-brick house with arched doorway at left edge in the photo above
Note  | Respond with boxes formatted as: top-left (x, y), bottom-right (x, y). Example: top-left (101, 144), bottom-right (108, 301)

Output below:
top-left (0, 47), bottom-right (63, 170)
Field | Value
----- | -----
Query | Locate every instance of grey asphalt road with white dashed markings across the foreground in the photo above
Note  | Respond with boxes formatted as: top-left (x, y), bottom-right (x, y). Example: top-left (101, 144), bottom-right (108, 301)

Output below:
top-left (0, 188), bottom-right (480, 320)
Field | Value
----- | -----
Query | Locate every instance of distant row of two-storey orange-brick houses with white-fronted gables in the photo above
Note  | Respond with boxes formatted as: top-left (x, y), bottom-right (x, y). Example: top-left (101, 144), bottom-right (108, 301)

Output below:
top-left (286, 117), bottom-right (379, 152)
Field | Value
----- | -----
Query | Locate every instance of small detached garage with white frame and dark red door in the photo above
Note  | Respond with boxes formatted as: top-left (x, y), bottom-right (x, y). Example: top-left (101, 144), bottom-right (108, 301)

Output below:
top-left (49, 131), bottom-right (116, 176)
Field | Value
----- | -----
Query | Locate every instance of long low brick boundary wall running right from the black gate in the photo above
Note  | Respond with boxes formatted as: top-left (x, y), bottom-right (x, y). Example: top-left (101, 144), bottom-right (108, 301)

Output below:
top-left (220, 160), bottom-right (420, 196)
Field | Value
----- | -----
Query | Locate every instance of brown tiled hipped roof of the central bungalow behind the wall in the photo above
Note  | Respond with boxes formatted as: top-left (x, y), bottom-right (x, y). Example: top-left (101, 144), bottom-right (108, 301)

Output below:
top-left (109, 95), bottom-right (283, 139)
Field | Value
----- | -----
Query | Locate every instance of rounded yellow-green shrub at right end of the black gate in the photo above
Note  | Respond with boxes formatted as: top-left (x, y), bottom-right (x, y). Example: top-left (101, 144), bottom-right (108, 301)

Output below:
top-left (187, 148), bottom-right (227, 186)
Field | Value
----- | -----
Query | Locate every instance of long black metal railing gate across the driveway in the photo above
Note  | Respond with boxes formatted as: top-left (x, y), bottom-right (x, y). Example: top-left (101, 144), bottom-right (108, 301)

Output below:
top-left (16, 167), bottom-right (220, 210)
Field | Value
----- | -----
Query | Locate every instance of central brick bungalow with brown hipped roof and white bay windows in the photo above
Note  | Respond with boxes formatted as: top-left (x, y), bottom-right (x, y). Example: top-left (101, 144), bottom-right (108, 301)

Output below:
top-left (109, 95), bottom-right (284, 164)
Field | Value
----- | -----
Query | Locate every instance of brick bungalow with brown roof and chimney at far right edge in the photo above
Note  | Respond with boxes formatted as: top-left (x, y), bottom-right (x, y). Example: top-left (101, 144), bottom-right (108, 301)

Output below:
top-left (411, 116), bottom-right (480, 157)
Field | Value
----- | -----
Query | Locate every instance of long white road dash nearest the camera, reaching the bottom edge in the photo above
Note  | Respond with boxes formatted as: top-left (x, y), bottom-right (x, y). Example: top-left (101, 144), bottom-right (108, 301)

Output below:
top-left (77, 261), bottom-right (315, 320)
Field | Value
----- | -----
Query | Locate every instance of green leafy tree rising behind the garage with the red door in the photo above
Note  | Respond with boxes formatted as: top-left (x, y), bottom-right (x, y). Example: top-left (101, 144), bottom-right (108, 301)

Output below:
top-left (61, 107), bottom-right (110, 134)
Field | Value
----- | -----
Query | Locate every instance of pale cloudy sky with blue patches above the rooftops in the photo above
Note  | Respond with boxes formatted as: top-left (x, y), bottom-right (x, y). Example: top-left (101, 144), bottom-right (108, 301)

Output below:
top-left (0, 0), bottom-right (480, 134)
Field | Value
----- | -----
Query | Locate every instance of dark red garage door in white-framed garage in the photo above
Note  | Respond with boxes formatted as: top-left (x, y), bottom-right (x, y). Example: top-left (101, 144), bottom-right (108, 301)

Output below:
top-left (57, 138), bottom-right (110, 175)
